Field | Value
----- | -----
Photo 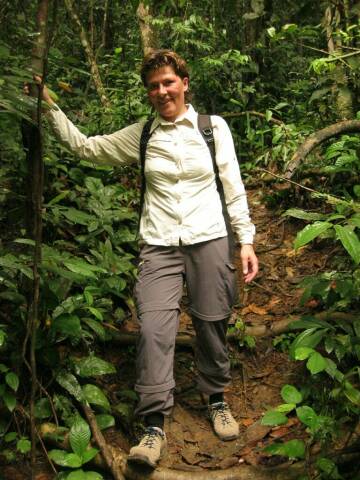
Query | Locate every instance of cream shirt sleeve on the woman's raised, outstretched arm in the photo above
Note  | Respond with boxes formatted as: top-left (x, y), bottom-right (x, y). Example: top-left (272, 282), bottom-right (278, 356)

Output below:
top-left (46, 106), bottom-right (143, 166)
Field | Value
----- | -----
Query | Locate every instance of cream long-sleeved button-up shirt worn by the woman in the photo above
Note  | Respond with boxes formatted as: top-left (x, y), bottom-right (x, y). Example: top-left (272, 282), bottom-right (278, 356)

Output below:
top-left (47, 105), bottom-right (255, 246)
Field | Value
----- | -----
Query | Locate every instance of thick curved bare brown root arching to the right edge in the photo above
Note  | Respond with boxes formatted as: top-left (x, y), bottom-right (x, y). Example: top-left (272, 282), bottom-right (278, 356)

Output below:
top-left (285, 120), bottom-right (360, 178)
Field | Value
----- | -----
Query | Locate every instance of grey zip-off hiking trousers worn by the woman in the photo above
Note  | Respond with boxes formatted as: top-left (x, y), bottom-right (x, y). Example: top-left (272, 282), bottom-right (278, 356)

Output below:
top-left (134, 237), bottom-right (238, 415)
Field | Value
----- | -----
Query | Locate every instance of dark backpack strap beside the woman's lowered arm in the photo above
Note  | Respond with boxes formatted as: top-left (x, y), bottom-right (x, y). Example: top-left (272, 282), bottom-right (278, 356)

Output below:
top-left (198, 114), bottom-right (235, 254)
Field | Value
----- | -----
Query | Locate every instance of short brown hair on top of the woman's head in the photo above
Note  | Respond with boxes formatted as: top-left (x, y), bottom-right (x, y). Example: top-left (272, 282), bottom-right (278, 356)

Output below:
top-left (140, 49), bottom-right (189, 87)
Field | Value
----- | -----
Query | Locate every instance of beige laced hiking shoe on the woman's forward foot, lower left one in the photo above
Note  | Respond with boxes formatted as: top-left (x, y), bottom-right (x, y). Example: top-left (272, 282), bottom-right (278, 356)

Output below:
top-left (128, 427), bottom-right (167, 468)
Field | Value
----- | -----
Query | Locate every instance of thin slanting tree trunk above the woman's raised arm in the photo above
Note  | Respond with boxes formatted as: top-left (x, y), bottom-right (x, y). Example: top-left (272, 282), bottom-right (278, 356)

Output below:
top-left (65, 0), bottom-right (110, 107)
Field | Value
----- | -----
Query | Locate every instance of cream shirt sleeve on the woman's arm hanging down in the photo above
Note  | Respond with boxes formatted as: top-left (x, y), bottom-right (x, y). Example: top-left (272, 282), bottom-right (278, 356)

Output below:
top-left (211, 116), bottom-right (255, 244)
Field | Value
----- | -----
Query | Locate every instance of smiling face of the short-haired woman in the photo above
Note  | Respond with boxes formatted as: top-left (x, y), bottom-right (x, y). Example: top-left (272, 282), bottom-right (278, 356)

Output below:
top-left (146, 66), bottom-right (189, 122)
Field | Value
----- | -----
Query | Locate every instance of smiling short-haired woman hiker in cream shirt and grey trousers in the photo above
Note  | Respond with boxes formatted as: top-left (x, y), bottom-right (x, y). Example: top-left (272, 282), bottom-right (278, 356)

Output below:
top-left (43, 50), bottom-right (258, 467)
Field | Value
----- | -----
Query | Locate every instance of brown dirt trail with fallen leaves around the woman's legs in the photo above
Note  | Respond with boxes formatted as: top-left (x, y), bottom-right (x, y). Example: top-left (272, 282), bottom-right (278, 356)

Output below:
top-left (0, 189), bottom-right (331, 480)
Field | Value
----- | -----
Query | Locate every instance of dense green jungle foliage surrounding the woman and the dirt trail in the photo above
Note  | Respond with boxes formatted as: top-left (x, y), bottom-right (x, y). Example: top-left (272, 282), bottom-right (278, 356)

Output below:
top-left (0, 0), bottom-right (360, 480)
